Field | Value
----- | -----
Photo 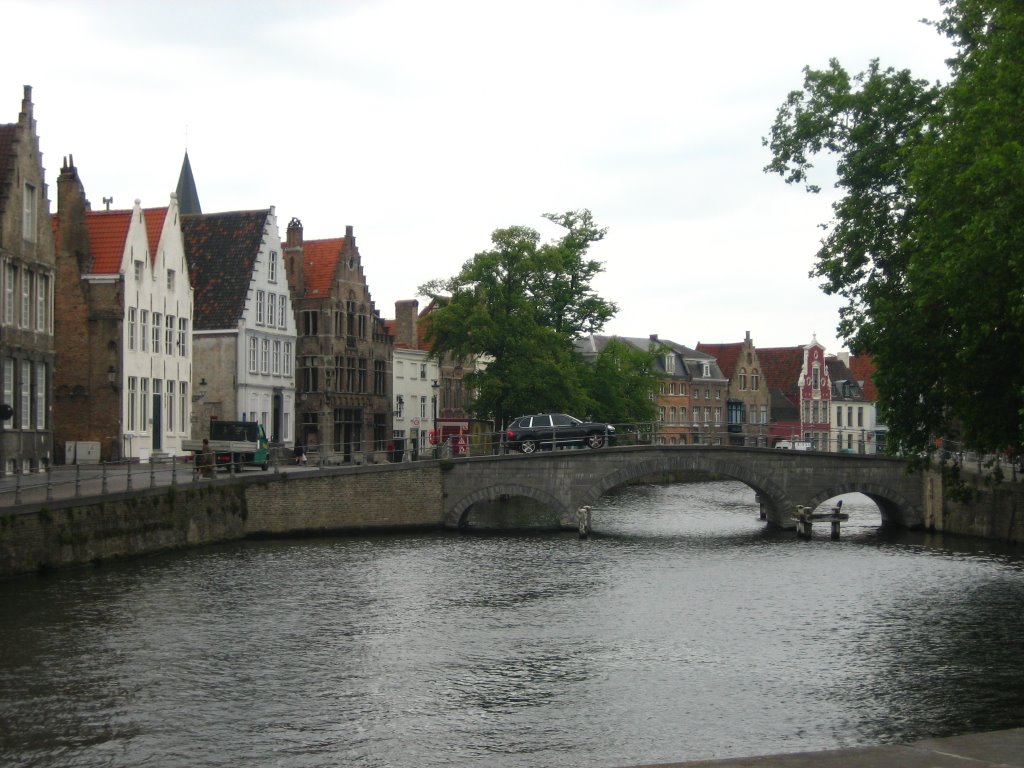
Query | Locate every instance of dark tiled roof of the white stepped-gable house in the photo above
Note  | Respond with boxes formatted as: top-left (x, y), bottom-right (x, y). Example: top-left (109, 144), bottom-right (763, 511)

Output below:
top-left (181, 210), bottom-right (270, 331)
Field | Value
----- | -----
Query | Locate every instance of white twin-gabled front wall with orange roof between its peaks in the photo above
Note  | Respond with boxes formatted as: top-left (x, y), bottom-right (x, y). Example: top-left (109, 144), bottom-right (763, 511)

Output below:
top-left (119, 194), bottom-right (193, 461)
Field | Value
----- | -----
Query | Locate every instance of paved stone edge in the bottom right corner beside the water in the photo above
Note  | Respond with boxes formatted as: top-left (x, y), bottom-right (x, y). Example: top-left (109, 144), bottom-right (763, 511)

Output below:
top-left (637, 728), bottom-right (1024, 768)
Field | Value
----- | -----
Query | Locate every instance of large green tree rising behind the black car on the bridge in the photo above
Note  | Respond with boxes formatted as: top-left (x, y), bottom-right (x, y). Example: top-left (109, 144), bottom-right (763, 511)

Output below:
top-left (420, 211), bottom-right (615, 425)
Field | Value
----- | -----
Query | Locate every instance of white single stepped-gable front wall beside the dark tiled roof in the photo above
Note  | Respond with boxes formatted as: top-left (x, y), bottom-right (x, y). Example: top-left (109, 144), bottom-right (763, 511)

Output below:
top-left (236, 206), bottom-right (296, 447)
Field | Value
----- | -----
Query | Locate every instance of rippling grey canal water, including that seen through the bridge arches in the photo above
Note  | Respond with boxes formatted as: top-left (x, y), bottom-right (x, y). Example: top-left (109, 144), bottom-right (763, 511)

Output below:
top-left (0, 482), bottom-right (1024, 768)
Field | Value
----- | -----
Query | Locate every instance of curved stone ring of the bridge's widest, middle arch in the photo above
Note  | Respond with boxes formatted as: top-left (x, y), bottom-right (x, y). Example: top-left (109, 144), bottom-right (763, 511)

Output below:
top-left (584, 453), bottom-right (796, 526)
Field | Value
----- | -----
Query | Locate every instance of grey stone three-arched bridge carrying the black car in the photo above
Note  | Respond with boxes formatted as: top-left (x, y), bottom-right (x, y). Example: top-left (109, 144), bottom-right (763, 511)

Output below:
top-left (443, 445), bottom-right (923, 528)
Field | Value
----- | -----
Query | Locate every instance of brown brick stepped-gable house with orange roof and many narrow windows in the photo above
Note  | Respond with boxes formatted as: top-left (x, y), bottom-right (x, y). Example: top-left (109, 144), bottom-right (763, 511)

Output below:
top-left (285, 218), bottom-right (393, 462)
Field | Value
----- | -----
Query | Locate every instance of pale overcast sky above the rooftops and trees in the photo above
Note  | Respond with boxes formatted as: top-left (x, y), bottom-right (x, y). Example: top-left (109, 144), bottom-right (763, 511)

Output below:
top-left (0, 0), bottom-right (950, 351)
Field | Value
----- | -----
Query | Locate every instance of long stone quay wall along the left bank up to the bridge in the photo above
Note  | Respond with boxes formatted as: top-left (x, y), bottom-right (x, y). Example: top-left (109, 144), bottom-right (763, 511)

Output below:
top-left (0, 462), bottom-right (443, 578)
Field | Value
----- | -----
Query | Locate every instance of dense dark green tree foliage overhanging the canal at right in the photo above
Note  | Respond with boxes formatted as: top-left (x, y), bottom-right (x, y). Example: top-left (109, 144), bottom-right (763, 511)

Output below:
top-left (765, 0), bottom-right (1024, 454)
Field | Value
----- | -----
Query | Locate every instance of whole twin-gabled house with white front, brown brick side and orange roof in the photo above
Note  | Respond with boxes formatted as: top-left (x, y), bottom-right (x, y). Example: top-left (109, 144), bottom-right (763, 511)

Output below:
top-left (53, 159), bottom-right (193, 462)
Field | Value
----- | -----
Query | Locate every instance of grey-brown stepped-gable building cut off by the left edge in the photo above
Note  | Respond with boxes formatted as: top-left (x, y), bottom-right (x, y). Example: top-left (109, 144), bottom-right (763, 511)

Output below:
top-left (0, 86), bottom-right (55, 475)
